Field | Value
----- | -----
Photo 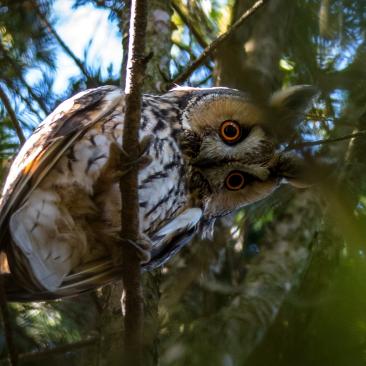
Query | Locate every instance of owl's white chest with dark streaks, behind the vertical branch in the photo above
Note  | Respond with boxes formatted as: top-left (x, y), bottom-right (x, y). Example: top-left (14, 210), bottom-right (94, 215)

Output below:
top-left (89, 101), bottom-right (188, 234)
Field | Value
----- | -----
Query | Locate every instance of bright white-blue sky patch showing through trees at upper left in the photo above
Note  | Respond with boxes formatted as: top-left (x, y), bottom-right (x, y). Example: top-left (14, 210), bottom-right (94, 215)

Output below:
top-left (26, 0), bottom-right (122, 94)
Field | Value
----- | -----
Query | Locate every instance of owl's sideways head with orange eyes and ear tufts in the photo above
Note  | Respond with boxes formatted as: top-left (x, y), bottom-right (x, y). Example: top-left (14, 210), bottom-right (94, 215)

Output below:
top-left (173, 85), bottom-right (317, 219)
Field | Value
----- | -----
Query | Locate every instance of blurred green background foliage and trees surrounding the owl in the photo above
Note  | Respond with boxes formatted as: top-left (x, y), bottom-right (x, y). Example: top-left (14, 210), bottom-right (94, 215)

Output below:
top-left (0, 0), bottom-right (366, 366)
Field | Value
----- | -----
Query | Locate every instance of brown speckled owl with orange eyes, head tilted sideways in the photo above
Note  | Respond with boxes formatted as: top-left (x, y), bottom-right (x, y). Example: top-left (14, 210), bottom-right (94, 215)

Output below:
top-left (0, 85), bottom-right (315, 300)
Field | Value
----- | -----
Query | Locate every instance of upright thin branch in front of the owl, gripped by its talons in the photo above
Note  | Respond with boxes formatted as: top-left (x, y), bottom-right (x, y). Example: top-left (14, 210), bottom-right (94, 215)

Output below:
top-left (120, 0), bottom-right (147, 366)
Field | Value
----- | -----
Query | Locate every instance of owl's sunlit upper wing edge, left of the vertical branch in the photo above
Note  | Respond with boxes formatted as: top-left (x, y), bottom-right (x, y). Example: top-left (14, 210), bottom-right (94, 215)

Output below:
top-left (0, 86), bottom-right (123, 247)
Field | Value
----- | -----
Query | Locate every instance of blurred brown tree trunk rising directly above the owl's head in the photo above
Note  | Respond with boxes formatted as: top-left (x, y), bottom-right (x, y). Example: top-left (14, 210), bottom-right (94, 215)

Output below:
top-left (216, 0), bottom-right (294, 98)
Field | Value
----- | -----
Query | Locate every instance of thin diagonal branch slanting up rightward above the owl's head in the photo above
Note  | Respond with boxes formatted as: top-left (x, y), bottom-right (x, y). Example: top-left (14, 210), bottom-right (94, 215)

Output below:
top-left (167, 0), bottom-right (269, 89)
